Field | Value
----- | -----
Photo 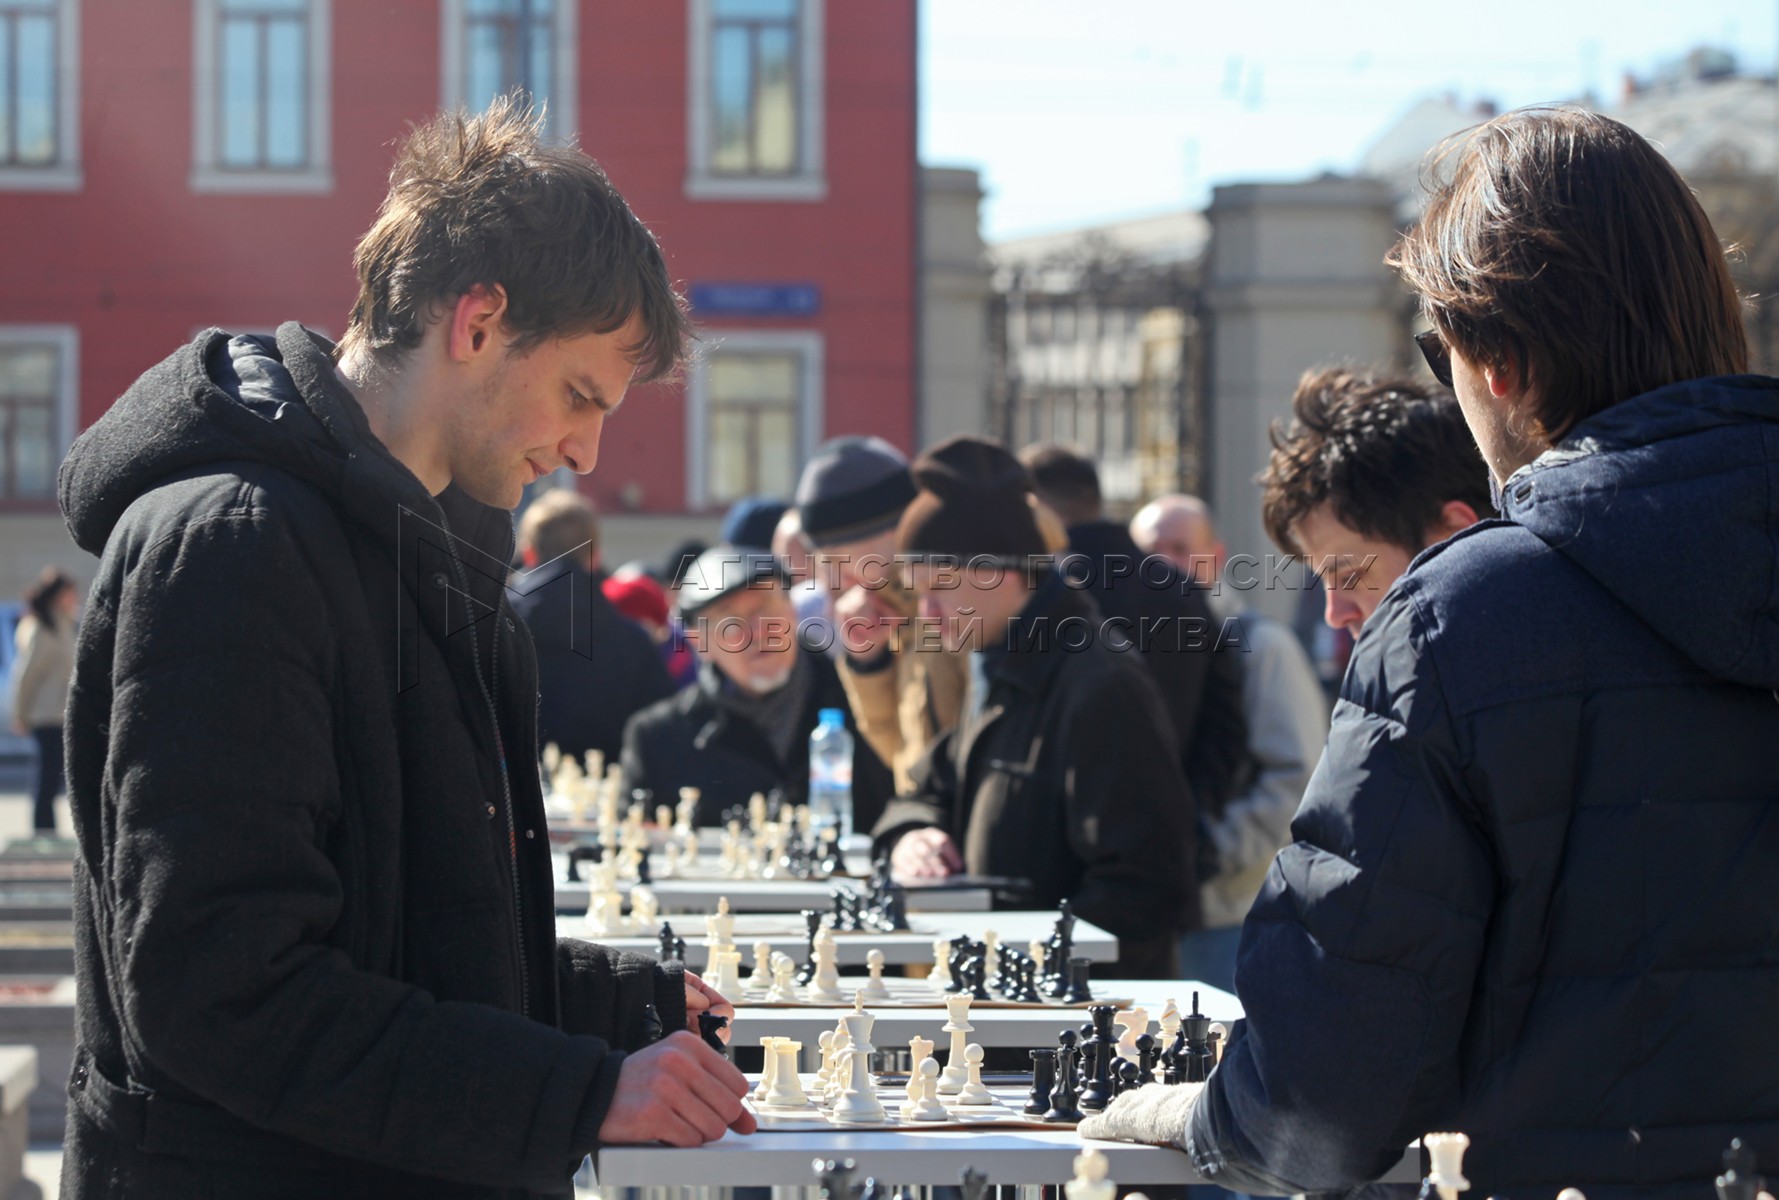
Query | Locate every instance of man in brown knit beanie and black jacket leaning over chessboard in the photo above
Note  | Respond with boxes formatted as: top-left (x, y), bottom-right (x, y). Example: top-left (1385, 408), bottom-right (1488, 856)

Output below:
top-left (875, 437), bottom-right (1197, 978)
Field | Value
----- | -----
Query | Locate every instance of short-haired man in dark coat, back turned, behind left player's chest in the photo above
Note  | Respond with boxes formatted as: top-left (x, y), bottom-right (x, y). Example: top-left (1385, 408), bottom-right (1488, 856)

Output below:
top-left (512, 489), bottom-right (674, 763)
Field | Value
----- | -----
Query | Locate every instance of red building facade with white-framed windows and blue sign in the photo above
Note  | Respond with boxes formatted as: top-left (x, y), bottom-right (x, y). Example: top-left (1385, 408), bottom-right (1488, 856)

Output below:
top-left (0, 0), bottom-right (918, 544)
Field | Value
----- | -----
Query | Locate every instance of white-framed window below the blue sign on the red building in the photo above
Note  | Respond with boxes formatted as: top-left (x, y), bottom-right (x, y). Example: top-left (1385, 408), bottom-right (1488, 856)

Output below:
top-left (687, 332), bottom-right (822, 508)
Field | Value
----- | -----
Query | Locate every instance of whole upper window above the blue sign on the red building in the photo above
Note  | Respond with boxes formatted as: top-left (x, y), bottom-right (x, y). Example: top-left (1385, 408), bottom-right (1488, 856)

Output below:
top-left (687, 0), bottom-right (827, 199)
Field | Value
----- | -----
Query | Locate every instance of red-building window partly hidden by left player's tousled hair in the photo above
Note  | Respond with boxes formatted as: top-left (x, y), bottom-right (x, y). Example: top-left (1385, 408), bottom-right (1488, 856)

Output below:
top-left (439, 0), bottom-right (578, 140)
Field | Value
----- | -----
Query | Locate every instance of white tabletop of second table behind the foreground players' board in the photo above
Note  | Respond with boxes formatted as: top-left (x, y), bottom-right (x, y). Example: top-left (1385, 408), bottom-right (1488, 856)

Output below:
top-left (583, 905), bottom-right (1117, 987)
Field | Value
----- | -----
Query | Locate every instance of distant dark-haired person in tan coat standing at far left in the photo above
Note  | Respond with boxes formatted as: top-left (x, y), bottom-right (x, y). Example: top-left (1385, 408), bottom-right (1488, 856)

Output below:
top-left (11, 567), bottom-right (80, 834)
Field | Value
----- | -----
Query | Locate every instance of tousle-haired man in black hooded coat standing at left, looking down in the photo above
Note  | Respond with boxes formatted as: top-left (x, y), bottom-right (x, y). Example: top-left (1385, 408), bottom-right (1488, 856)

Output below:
top-left (60, 101), bottom-right (751, 1198)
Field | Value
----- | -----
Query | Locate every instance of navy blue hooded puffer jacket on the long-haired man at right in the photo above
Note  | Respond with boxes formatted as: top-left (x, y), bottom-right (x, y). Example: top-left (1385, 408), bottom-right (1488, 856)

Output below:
top-left (1188, 377), bottom-right (1779, 1200)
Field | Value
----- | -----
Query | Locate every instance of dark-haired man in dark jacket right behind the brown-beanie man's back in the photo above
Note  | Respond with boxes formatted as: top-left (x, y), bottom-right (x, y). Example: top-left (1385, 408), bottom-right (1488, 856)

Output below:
top-left (1019, 443), bottom-right (1252, 850)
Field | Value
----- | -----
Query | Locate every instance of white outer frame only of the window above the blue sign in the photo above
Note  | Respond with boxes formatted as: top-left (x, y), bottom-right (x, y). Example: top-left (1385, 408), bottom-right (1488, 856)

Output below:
top-left (685, 0), bottom-right (827, 201)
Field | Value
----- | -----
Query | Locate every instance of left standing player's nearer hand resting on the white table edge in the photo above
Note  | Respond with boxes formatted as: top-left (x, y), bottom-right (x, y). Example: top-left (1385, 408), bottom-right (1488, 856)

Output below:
top-left (600, 1031), bottom-right (754, 1147)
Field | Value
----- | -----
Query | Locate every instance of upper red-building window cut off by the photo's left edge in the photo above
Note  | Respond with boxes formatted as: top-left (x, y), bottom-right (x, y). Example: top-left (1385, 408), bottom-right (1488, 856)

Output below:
top-left (0, 0), bottom-right (80, 190)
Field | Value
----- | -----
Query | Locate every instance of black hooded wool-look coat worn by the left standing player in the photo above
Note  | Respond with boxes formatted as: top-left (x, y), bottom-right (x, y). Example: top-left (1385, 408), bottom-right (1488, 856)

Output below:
top-left (60, 324), bottom-right (685, 1198)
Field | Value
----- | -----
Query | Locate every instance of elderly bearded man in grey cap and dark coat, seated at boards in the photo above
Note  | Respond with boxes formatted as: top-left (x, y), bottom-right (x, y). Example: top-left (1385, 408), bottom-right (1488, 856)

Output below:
top-left (623, 546), bottom-right (891, 827)
